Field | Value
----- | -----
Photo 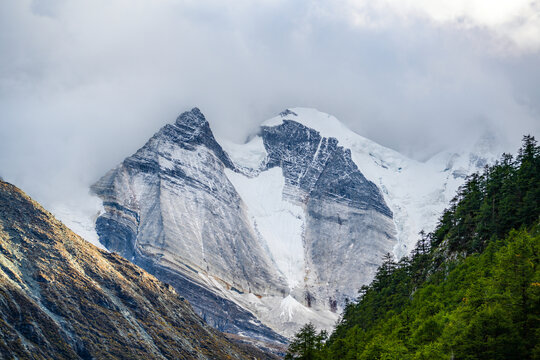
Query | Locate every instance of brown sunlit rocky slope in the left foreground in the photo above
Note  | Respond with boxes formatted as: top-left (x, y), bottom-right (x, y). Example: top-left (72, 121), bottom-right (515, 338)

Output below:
top-left (0, 181), bottom-right (270, 359)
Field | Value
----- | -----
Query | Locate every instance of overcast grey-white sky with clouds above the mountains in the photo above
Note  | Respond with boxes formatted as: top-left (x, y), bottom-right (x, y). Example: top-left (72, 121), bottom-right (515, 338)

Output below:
top-left (0, 0), bottom-right (540, 208)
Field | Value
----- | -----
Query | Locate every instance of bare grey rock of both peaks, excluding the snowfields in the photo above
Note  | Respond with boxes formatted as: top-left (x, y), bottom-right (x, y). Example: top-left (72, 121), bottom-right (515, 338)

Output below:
top-left (92, 109), bottom-right (396, 341)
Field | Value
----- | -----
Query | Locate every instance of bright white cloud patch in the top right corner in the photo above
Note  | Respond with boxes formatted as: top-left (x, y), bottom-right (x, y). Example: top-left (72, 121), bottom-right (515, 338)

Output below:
top-left (344, 0), bottom-right (540, 55)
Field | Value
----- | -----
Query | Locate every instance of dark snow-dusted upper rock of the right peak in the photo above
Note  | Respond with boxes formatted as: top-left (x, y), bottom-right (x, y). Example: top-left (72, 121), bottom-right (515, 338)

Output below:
top-left (262, 118), bottom-right (392, 217)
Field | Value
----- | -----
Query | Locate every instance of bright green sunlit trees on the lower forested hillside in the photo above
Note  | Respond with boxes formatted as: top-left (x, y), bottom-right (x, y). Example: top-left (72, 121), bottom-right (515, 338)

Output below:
top-left (324, 229), bottom-right (540, 359)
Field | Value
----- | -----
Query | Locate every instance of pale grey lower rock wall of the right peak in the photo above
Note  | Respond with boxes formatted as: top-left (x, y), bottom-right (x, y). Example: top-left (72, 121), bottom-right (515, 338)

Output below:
top-left (304, 198), bottom-right (396, 311)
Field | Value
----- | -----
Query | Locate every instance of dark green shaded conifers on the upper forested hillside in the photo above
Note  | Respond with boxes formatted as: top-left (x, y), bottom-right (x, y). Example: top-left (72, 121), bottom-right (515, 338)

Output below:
top-left (431, 136), bottom-right (540, 254)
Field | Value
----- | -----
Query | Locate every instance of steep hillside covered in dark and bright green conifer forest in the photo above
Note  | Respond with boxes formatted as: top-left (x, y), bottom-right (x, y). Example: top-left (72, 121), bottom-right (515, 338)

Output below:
top-left (287, 136), bottom-right (540, 359)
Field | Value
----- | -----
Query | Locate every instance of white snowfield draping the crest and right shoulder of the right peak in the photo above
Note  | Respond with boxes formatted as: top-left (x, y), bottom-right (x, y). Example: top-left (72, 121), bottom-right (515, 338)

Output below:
top-left (262, 108), bottom-right (499, 258)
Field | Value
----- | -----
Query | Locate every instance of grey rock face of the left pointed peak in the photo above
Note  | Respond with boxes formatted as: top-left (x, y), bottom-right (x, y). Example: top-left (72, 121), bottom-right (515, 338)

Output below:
top-left (92, 109), bottom-right (285, 339)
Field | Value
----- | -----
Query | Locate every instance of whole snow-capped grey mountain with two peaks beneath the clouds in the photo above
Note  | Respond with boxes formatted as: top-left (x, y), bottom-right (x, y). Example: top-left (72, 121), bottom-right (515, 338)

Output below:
top-left (85, 108), bottom-right (493, 341)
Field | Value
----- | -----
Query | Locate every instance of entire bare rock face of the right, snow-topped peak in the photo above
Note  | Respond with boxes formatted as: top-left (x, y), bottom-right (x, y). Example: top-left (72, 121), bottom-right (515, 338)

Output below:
top-left (261, 119), bottom-right (395, 310)
